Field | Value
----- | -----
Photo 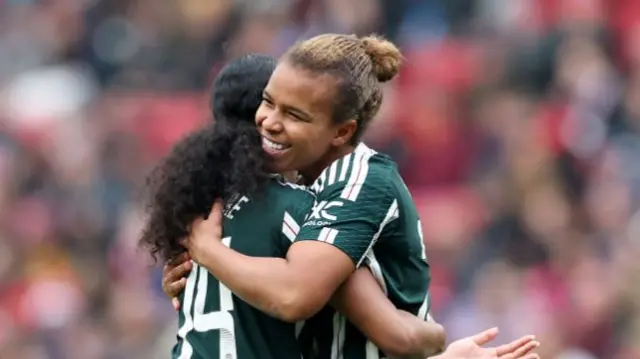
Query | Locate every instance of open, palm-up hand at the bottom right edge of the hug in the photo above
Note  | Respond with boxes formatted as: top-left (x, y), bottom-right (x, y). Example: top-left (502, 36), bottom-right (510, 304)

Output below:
top-left (432, 328), bottom-right (540, 359)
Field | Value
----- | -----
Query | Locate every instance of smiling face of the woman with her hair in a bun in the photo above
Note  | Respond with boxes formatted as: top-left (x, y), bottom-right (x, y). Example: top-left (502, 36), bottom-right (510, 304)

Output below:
top-left (256, 61), bottom-right (356, 180)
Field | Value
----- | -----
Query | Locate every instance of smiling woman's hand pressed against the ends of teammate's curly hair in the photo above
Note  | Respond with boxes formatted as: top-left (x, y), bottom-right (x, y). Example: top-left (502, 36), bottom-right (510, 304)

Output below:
top-left (180, 200), bottom-right (223, 264)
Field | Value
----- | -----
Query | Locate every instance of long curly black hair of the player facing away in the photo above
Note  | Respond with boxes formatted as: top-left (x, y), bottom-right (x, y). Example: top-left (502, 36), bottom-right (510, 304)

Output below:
top-left (139, 55), bottom-right (276, 261)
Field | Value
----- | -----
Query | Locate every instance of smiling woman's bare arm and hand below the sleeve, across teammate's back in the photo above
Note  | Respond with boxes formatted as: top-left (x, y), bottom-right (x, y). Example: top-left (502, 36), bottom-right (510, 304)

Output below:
top-left (183, 202), bottom-right (355, 322)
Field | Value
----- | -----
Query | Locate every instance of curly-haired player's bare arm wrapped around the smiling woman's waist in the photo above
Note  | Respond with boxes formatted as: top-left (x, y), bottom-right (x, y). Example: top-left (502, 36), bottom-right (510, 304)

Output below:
top-left (331, 268), bottom-right (445, 359)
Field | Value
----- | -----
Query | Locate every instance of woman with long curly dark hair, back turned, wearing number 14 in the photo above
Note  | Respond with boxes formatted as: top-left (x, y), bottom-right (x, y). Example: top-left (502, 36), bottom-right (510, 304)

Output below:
top-left (140, 55), bottom-right (444, 359)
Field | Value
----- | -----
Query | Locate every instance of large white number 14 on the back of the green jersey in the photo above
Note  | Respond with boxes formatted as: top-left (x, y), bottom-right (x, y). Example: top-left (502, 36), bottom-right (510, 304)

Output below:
top-left (178, 237), bottom-right (238, 359)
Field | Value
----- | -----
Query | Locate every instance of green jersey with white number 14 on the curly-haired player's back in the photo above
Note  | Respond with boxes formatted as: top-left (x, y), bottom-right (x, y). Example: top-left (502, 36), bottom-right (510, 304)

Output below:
top-left (172, 179), bottom-right (314, 359)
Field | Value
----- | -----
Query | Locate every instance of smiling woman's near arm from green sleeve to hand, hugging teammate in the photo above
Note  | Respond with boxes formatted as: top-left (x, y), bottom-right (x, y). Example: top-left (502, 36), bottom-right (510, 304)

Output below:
top-left (186, 173), bottom-right (395, 322)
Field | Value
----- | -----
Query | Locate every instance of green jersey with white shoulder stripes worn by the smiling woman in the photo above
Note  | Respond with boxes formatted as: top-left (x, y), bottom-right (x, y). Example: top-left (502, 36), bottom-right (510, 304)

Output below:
top-left (296, 144), bottom-right (430, 359)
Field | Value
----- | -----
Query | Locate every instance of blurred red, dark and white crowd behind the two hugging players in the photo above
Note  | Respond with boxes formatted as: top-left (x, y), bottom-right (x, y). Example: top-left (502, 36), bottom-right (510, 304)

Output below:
top-left (0, 0), bottom-right (640, 359)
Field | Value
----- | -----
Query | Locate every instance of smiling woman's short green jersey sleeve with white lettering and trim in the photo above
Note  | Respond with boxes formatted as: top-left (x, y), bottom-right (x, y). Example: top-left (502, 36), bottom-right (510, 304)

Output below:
top-left (296, 170), bottom-right (398, 267)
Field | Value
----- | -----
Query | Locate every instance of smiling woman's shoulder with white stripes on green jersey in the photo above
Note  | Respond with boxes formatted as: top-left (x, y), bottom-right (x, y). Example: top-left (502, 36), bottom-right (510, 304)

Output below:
top-left (309, 143), bottom-right (397, 201)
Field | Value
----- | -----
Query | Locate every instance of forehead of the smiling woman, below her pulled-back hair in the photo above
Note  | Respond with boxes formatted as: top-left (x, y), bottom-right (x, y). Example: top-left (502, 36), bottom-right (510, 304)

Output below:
top-left (266, 61), bottom-right (337, 112)
